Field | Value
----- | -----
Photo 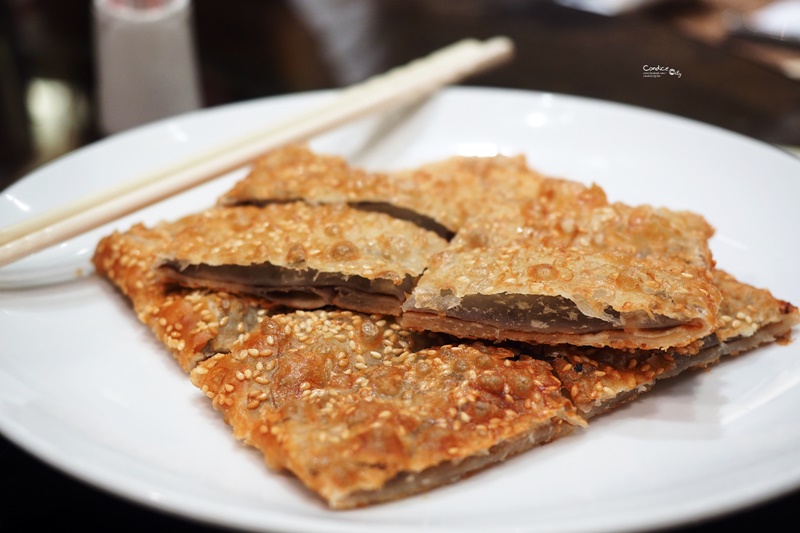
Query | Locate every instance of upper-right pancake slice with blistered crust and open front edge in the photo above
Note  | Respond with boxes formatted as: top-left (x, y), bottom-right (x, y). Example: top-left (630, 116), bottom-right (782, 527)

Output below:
top-left (402, 178), bottom-right (720, 349)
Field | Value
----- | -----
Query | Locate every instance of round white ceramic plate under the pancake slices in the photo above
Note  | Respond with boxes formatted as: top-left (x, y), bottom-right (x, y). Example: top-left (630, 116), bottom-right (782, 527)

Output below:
top-left (0, 88), bottom-right (800, 532)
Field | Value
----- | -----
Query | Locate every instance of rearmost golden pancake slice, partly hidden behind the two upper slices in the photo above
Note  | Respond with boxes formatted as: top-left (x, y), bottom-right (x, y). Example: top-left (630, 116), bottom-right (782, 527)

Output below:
top-left (219, 145), bottom-right (541, 239)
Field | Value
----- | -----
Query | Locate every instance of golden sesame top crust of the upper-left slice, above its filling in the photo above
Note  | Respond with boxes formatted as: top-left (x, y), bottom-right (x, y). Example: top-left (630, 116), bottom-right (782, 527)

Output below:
top-left (162, 202), bottom-right (446, 278)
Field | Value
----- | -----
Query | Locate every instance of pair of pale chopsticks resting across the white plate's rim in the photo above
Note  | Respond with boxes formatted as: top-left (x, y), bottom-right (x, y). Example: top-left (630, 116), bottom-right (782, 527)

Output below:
top-left (0, 37), bottom-right (513, 266)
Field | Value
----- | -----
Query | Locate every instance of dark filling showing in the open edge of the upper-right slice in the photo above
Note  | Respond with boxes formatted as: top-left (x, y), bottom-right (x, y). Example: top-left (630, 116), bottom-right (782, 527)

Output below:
top-left (406, 293), bottom-right (683, 333)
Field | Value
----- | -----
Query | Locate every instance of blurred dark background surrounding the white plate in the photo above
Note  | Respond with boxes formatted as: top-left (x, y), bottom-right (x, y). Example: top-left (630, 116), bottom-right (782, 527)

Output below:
top-left (0, 0), bottom-right (800, 531)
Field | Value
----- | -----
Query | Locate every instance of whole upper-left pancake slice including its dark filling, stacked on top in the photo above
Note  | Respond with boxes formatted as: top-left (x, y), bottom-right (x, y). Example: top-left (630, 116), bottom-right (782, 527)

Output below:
top-left (152, 202), bottom-right (446, 315)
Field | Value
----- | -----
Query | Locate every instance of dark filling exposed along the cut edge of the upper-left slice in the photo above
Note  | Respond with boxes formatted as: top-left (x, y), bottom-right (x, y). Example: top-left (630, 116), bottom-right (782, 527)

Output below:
top-left (159, 261), bottom-right (416, 315)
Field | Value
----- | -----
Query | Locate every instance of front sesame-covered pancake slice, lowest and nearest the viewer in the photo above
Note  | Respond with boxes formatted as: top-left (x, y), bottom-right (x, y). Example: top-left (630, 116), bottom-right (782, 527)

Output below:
top-left (191, 311), bottom-right (585, 509)
